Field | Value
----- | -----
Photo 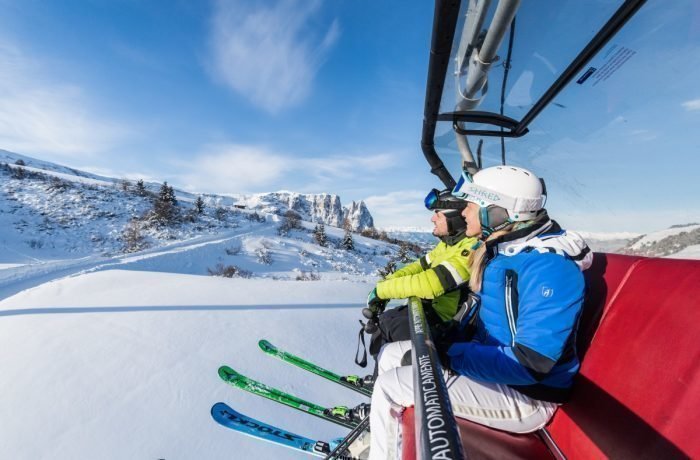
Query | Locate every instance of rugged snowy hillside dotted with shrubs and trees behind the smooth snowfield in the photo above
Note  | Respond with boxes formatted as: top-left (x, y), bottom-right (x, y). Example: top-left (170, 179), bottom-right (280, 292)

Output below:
top-left (0, 151), bottom-right (410, 298)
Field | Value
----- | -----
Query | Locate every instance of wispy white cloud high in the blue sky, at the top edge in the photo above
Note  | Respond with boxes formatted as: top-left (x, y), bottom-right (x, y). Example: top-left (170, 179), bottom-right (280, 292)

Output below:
top-left (211, 0), bottom-right (340, 113)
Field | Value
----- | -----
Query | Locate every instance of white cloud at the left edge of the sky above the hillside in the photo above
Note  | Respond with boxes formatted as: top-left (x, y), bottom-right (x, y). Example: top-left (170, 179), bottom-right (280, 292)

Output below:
top-left (0, 42), bottom-right (128, 158)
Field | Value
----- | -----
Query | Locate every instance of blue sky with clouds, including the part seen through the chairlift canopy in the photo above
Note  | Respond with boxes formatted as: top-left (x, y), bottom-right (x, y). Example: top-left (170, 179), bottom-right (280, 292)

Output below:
top-left (0, 0), bottom-right (700, 231)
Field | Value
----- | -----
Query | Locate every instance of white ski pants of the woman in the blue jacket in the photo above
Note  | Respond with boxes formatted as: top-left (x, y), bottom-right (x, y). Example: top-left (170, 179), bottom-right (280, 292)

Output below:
top-left (369, 340), bottom-right (557, 460)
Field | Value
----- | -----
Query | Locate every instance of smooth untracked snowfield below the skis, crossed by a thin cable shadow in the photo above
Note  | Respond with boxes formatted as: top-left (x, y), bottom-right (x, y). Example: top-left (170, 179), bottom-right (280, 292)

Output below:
top-left (0, 270), bottom-right (371, 459)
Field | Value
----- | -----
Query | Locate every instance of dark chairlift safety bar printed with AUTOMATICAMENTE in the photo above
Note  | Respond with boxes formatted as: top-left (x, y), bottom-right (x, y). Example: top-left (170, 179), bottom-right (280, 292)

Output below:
top-left (408, 297), bottom-right (466, 460)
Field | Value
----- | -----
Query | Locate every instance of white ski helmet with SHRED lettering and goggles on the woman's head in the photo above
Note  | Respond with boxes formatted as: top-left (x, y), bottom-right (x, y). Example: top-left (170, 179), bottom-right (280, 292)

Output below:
top-left (452, 166), bottom-right (546, 222)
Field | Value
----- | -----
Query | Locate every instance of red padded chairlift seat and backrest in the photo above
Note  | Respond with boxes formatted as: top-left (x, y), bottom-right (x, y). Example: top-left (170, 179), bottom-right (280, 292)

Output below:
top-left (402, 254), bottom-right (700, 460)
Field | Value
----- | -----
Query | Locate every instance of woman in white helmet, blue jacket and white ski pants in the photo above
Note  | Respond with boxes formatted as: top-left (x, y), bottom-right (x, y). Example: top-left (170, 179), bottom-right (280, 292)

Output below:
top-left (370, 166), bottom-right (592, 459)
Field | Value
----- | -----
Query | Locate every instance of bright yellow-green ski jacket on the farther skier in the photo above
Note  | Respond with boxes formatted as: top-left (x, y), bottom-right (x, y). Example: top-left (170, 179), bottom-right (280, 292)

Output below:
top-left (377, 237), bottom-right (478, 321)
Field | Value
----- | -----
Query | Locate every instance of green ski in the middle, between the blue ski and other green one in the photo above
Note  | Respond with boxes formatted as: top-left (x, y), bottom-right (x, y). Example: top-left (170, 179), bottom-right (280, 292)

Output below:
top-left (219, 366), bottom-right (357, 428)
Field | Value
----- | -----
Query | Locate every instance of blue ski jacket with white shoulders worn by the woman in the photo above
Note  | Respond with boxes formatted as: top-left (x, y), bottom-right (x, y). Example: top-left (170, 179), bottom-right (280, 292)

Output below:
top-left (448, 218), bottom-right (592, 402)
